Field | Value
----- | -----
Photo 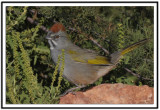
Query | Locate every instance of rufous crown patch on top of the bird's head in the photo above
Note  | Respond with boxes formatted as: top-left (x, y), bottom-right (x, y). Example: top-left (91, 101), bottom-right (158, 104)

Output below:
top-left (50, 23), bottom-right (66, 33)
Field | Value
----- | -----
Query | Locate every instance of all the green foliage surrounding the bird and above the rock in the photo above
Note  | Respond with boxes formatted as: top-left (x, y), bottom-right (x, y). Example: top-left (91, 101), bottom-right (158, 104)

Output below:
top-left (6, 6), bottom-right (154, 104)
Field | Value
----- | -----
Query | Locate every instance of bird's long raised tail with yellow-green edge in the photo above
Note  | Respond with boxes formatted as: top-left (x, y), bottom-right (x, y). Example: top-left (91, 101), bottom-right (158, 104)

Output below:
top-left (111, 38), bottom-right (151, 64)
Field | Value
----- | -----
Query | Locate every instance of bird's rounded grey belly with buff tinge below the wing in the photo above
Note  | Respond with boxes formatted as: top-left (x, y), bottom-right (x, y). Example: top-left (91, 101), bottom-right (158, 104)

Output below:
top-left (63, 62), bottom-right (102, 85)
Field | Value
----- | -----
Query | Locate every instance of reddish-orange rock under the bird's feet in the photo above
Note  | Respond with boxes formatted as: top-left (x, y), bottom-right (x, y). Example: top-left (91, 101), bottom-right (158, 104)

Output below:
top-left (60, 83), bottom-right (154, 104)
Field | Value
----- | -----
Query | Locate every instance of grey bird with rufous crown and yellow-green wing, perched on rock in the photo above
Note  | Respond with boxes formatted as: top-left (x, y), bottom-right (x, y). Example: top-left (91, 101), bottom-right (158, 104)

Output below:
top-left (45, 22), bottom-right (150, 96)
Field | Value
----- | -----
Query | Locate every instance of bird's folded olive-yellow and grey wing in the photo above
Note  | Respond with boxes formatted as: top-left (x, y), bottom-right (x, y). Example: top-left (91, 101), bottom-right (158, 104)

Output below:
top-left (67, 50), bottom-right (111, 65)
